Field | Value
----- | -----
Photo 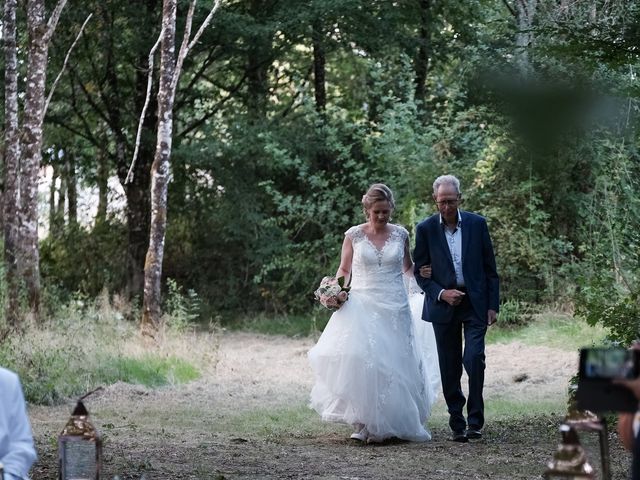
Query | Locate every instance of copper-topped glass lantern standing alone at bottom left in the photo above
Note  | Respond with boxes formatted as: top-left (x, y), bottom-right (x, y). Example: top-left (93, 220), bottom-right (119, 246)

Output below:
top-left (58, 400), bottom-right (102, 480)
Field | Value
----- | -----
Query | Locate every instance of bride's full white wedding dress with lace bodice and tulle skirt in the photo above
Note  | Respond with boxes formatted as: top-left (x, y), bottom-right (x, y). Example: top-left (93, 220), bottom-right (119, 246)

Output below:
top-left (308, 225), bottom-right (440, 441)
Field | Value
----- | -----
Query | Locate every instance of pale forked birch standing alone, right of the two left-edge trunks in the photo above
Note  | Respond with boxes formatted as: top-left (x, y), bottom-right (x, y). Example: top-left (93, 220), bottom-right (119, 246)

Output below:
top-left (139, 0), bottom-right (220, 335)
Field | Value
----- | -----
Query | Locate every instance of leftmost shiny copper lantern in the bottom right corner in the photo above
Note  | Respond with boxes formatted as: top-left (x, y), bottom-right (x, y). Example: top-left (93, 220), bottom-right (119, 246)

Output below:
top-left (544, 424), bottom-right (596, 480)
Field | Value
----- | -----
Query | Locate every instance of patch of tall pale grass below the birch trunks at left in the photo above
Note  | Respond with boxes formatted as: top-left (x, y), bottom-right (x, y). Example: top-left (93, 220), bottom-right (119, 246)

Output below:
top-left (0, 293), bottom-right (218, 404)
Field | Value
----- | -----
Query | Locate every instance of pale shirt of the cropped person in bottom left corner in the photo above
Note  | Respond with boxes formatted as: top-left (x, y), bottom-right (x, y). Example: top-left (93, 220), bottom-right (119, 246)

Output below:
top-left (0, 367), bottom-right (37, 480)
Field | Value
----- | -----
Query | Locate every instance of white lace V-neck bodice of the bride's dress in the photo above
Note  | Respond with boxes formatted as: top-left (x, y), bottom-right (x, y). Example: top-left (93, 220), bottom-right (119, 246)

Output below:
top-left (345, 225), bottom-right (409, 291)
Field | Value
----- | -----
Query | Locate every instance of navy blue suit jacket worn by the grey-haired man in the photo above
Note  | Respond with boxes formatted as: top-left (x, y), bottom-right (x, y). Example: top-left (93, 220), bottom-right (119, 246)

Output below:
top-left (413, 210), bottom-right (500, 323)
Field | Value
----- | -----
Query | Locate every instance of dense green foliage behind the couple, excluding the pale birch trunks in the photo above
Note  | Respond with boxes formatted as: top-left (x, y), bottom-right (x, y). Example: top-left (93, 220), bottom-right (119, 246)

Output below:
top-left (11, 0), bottom-right (640, 322)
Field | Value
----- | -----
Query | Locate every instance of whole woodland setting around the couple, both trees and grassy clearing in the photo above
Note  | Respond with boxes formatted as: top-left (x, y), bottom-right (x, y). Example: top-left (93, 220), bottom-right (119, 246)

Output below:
top-left (0, 0), bottom-right (640, 480)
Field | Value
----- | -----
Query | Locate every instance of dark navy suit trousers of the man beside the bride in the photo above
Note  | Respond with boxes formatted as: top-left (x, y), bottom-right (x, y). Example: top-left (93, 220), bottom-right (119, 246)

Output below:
top-left (433, 297), bottom-right (487, 432)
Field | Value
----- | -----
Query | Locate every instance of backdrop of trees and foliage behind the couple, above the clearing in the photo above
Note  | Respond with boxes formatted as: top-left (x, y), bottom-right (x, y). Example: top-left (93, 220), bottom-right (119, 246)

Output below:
top-left (1, 0), bottom-right (640, 344)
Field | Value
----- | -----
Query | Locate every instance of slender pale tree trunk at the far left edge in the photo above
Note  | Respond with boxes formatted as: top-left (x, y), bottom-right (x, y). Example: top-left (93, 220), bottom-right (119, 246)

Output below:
top-left (3, 0), bottom-right (20, 328)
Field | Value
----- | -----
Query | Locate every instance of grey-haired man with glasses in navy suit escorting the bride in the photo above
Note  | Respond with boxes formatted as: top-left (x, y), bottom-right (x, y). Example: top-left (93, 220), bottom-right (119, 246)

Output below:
top-left (413, 175), bottom-right (499, 442)
